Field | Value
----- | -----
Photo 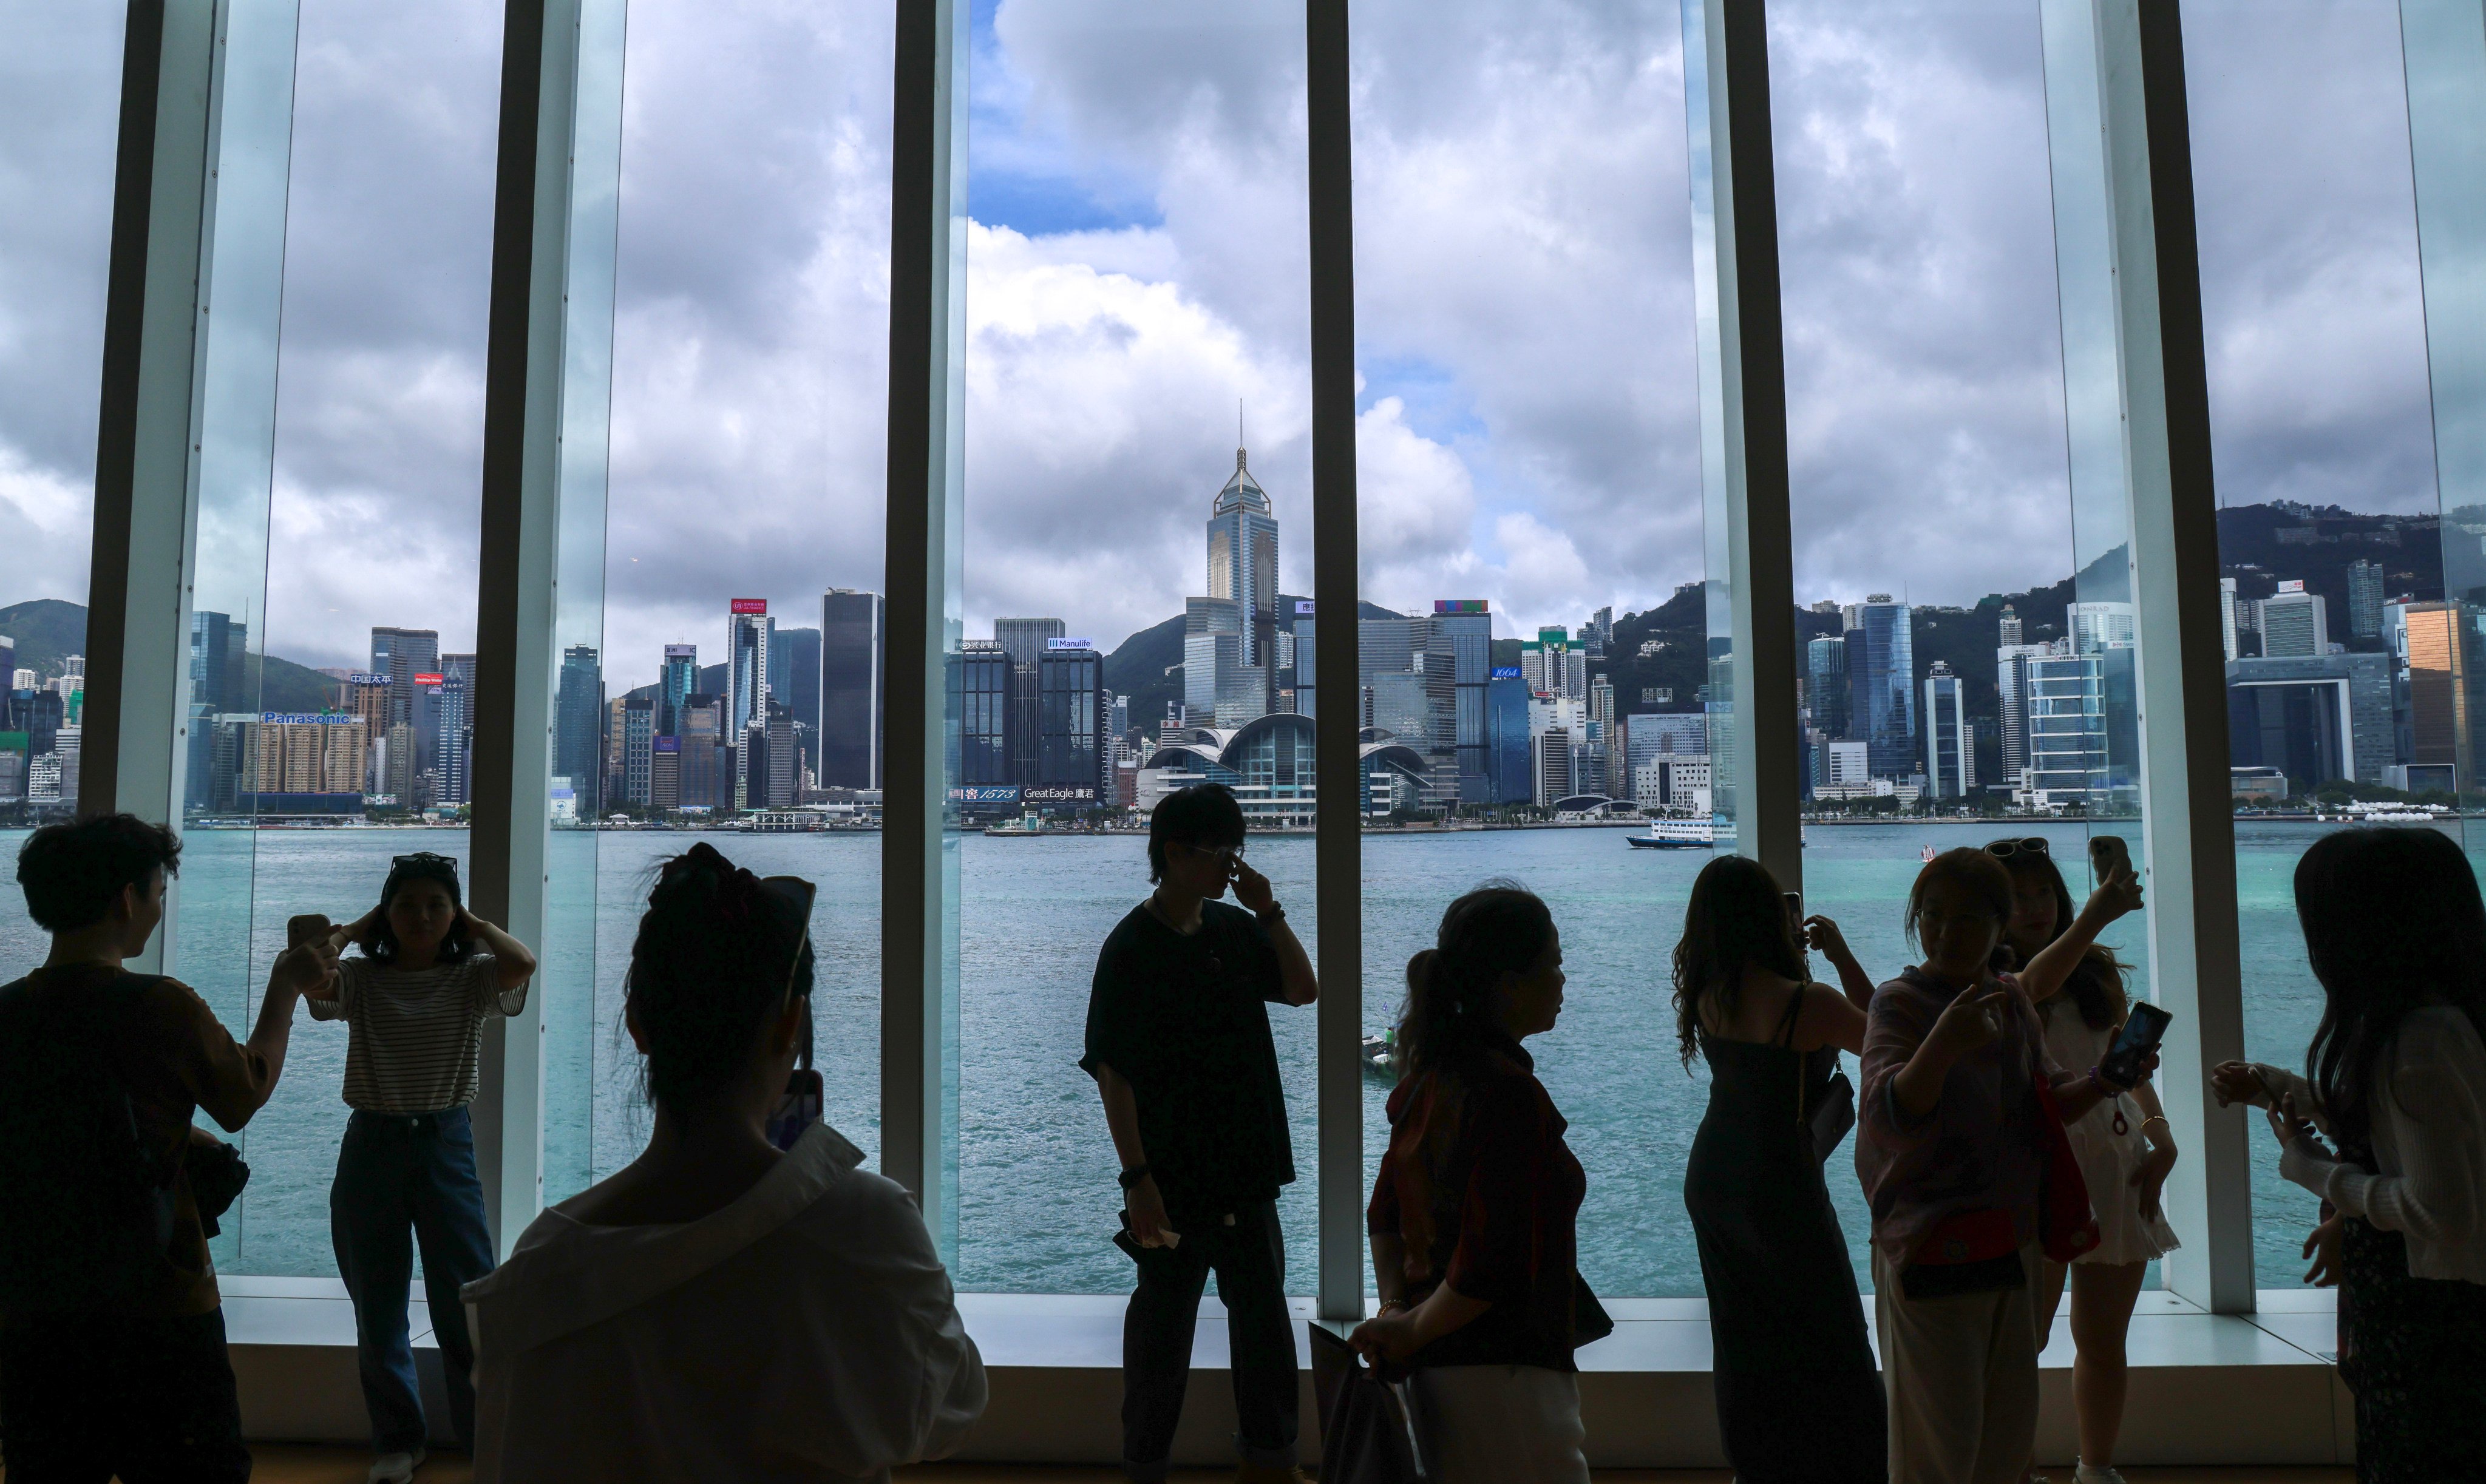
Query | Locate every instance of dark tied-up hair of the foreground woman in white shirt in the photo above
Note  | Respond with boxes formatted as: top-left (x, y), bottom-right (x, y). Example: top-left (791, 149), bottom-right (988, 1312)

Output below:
top-left (624, 840), bottom-right (813, 1116)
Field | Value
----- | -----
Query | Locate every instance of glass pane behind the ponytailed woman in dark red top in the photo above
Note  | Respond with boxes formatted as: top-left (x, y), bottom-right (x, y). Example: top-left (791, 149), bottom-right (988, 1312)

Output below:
top-left (1342, 0), bottom-right (1710, 1295)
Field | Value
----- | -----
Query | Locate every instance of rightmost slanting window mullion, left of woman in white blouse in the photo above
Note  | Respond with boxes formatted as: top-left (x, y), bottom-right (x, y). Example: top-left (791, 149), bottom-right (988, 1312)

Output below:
top-left (2041, 0), bottom-right (2255, 1312)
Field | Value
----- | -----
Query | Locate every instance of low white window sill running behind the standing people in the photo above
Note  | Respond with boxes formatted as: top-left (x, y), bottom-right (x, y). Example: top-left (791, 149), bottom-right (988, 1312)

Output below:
top-left (221, 1278), bottom-right (2354, 1469)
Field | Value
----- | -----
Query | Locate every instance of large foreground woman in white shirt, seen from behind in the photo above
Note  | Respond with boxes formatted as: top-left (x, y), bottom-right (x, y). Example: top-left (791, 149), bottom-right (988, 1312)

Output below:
top-left (465, 842), bottom-right (985, 1484)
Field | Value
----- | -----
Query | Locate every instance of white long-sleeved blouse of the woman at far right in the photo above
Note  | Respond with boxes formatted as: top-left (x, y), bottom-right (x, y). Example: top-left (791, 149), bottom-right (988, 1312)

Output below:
top-left (2262, 1005), bottom-right (2486, 1282)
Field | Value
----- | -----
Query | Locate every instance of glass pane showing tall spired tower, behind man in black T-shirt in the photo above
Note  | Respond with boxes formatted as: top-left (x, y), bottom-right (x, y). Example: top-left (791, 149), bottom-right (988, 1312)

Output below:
top-left (947, 0), bottom-right (1317, 1293)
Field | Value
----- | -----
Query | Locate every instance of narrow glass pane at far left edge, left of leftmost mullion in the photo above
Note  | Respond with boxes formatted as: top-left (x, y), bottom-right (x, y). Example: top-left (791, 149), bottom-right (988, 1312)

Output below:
top-left (0, 5), bottom-right (122, 949)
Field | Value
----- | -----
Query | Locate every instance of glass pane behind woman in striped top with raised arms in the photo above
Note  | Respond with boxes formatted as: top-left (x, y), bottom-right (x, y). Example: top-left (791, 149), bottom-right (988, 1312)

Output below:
top-left (214, 0), bottom-right (502, 1275)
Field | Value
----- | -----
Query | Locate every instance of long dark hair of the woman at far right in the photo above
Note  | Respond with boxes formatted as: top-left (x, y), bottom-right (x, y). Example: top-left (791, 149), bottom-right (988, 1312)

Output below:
top-left (2295, 825), bottom-right (2486, 1168)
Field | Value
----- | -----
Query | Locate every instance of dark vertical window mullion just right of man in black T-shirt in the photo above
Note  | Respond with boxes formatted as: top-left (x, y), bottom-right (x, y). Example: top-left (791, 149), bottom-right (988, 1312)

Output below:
top-left (1305, 0), bottom-right (1365, 1320)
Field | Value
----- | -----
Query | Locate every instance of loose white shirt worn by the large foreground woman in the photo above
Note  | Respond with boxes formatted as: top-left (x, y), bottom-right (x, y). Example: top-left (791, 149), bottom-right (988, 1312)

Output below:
top-left (465, 1123), bottom-right (985, 1484)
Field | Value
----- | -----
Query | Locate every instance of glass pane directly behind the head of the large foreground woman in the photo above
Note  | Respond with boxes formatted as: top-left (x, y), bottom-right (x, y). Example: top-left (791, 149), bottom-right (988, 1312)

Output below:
top-left (569, 0), bottom-right (892, 1201)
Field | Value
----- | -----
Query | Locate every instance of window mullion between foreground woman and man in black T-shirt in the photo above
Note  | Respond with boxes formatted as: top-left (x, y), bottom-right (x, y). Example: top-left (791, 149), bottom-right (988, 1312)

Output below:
top-left (880, 0), bottom-right (967, 1263)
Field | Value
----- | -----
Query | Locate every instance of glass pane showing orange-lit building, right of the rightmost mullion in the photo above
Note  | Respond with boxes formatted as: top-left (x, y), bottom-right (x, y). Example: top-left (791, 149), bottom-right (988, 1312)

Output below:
top-left (2185, 0), bottom-right (2436, 1287)
